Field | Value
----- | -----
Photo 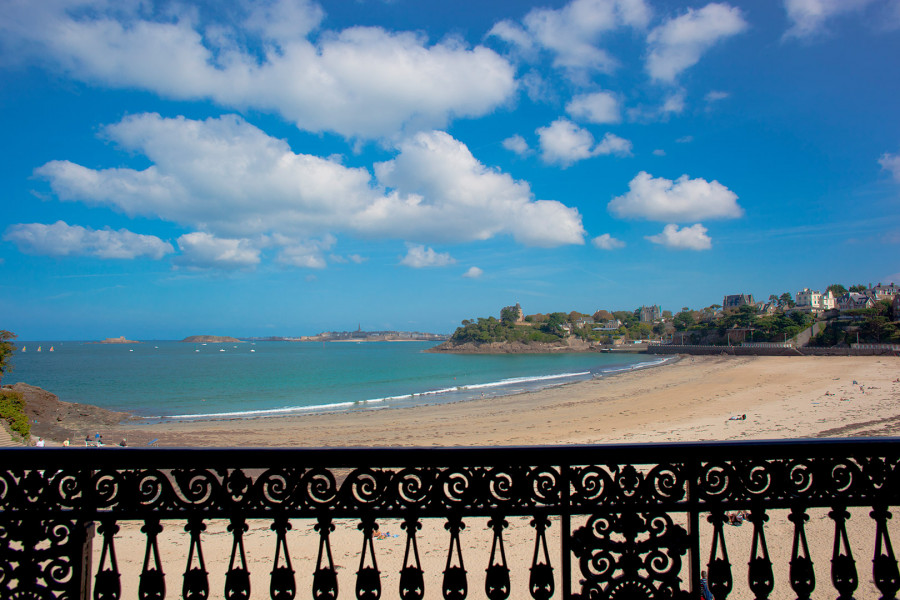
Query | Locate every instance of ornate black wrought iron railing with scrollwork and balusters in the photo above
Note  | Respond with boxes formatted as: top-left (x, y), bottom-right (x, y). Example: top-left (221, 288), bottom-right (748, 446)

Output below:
top-left (0, 438), bottom-right (900, 600)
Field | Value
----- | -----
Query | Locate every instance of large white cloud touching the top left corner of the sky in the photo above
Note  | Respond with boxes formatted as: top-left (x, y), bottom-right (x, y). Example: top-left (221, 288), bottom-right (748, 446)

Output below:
top-left (0, 0), bottom-right (516, 138)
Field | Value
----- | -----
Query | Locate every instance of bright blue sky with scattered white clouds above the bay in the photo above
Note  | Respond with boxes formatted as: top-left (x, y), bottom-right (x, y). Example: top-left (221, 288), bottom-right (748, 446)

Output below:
top-left (0, 0), bottom-right (900, 339)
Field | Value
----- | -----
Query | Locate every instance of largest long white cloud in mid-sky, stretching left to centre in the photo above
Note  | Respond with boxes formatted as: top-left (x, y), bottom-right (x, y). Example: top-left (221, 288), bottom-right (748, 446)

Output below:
top-left (35, 114), bottom-right (584, 268)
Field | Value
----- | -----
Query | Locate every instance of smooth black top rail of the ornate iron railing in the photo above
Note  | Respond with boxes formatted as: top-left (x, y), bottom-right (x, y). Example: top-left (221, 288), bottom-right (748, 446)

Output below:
top-left (0, 437), bottom-right (900, 469)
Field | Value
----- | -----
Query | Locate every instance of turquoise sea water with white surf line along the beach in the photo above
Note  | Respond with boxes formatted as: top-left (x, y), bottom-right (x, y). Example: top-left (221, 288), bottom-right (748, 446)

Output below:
top-left (3, 341), bottom-right (661, 419)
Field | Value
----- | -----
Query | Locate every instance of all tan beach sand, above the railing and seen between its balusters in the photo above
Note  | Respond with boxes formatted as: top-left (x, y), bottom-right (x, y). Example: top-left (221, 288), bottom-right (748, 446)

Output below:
top-left (28, 356), bottom-right (900, 599)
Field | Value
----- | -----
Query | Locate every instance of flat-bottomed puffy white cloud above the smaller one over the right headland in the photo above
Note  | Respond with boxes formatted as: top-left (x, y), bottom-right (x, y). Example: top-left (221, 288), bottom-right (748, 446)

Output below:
top-left (607, 171), bottom-right (744, 223)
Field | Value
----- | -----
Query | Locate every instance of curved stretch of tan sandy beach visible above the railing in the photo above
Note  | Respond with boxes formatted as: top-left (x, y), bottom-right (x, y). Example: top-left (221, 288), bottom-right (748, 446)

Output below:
top-left (22, 356), bottom-right (900, 448)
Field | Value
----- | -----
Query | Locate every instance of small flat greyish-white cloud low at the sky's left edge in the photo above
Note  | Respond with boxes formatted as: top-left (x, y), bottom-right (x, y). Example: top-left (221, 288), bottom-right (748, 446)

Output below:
top-left (3, 221), bottom-right (174, 259)
